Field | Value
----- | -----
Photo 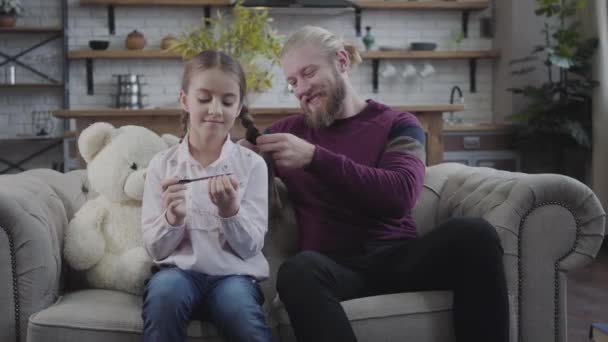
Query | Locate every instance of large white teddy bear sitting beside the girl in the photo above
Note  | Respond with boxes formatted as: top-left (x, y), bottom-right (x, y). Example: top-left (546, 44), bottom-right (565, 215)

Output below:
top-left (64, 122), bottom-right (179, 294)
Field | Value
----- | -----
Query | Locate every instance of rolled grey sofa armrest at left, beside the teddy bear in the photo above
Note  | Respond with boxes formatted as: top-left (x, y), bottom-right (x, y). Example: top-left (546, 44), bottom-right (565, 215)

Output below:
top-left (0, 173), bottom-right (67, 342)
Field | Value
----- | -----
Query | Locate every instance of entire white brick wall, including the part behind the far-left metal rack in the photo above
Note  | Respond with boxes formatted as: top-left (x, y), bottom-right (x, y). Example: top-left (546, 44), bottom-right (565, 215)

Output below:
top-left (0, 0), bottom-right (494, 167)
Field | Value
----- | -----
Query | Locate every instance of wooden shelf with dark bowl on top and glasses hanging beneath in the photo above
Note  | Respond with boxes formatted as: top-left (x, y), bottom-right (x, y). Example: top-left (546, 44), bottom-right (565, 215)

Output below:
top-left (361, 50), bottom-right (500, 93)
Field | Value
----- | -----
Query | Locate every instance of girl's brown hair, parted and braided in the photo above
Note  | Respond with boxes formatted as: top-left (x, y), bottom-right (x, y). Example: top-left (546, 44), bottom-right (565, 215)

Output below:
top-left (180, 50), bottom-right (253, 138)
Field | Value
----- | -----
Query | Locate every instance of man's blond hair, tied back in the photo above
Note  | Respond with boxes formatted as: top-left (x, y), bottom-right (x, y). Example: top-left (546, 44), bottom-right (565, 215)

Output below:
top-left (281, 26), bottom-right (361, 69)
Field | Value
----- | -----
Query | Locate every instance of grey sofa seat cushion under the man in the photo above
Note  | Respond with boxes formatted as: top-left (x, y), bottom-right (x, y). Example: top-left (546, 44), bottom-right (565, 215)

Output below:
top-left (273, 291), bottom-right (454, 342)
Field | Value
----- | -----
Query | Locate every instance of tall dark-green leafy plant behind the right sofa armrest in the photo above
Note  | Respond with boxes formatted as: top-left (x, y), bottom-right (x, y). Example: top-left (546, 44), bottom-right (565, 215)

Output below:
top-left (508, 0), bottom-right (598, 181)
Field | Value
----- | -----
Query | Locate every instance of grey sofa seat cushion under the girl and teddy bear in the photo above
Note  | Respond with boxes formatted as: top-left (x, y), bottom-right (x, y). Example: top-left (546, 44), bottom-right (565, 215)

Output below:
top-left (28, 290), bottom-right (264, 342)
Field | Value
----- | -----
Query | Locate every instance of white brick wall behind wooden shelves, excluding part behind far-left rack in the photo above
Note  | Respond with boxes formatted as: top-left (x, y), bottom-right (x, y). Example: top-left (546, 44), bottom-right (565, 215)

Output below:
top-left (69, 0), bottom-right (493, 122)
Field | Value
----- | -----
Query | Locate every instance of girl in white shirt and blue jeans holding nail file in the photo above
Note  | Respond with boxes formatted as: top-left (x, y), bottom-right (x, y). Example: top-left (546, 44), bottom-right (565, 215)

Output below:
top-left (142, 51), bottom-right (272, 341)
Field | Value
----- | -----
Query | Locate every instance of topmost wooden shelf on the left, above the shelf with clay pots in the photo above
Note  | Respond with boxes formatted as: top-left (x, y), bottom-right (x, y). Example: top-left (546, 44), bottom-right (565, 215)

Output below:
top-left (80, 0), bottom-right (233, 35)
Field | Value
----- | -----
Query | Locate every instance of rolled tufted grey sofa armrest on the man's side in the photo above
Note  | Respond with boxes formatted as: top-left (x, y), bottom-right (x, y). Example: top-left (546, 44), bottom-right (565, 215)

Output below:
top-left (430, 164), bottom-right (606, 341)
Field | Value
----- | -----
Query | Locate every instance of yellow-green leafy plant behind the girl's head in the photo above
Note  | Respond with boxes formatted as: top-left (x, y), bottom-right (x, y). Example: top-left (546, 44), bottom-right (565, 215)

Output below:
top-left (169, 0), bottom-right (282, 92)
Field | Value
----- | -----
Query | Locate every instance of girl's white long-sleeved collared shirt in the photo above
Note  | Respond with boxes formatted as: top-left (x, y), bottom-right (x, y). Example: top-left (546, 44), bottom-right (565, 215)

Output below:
top-left (142, 137), bottom-right (268, 280)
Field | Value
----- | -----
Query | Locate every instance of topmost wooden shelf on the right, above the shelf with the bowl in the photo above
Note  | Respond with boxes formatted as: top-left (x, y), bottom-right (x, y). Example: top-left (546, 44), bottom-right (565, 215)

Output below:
top-left (355, 0), bottom-right (490, 38)
